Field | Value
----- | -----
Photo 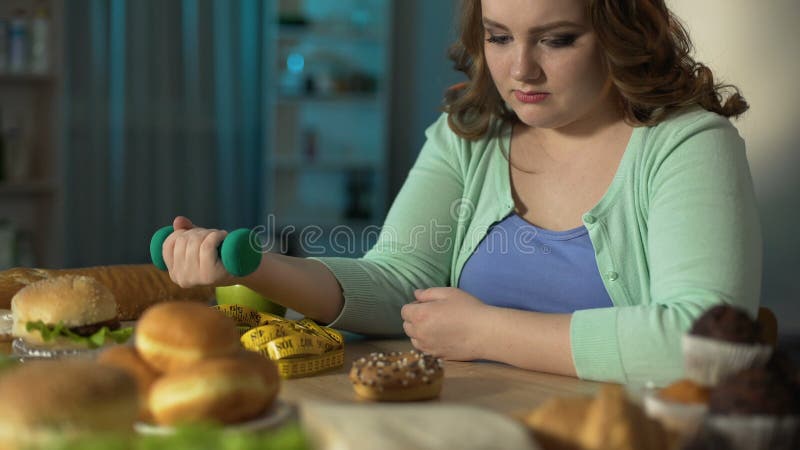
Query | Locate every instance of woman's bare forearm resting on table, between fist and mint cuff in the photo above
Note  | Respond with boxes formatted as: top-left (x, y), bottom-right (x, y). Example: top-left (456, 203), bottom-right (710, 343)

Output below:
top-left (481, 307), bottom-right (577, 377)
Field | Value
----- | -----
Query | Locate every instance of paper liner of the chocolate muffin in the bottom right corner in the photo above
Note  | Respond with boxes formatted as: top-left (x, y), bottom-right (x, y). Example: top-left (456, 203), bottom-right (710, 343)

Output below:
top-left (705, 415), bottom-right (800, 450)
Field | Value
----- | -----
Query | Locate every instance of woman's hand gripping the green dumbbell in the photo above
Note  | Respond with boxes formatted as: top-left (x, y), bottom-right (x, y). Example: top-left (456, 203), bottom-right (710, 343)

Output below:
top-left (161, 216), bottom-right (235, 288)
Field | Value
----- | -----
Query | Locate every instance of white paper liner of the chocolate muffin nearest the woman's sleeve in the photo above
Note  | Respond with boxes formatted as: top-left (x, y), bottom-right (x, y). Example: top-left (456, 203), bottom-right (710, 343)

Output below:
top-left (683, 334), bottom-right (772, 386)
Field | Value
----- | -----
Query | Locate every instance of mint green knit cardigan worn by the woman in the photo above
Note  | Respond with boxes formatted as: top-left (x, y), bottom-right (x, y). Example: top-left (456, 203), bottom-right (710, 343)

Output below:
top-left (316, 108), bottom-right (762, 384)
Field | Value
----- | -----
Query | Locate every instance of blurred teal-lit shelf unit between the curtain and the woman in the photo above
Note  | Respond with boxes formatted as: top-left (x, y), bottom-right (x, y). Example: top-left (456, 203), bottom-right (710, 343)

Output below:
top-left (266, 0), bottom-right (393, 256)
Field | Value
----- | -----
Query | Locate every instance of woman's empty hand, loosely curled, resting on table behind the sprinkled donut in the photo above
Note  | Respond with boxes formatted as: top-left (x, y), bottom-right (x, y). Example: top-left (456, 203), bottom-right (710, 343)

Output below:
top-left (400, 287), bottom-right (491, 361)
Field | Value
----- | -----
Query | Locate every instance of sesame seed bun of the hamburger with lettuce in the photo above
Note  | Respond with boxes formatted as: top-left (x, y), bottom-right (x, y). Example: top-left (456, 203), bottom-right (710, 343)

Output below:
top-left (11, 275), bottom-right (117, 349)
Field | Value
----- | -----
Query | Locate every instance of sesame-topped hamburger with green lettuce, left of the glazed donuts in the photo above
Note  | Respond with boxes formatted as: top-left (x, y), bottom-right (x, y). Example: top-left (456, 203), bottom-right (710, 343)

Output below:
top-left (11, 275), bottom-right (133, 350)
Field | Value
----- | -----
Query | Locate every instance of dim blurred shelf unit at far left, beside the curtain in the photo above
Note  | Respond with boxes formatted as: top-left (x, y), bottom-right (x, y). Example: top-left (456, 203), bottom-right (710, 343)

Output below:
top-left (0, 0), bottom-right (63, 270)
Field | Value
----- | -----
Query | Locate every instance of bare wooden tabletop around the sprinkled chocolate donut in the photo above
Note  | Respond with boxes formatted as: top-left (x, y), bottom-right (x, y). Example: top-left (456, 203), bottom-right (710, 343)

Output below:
top-left (280, 339), bottom-right (600, 415)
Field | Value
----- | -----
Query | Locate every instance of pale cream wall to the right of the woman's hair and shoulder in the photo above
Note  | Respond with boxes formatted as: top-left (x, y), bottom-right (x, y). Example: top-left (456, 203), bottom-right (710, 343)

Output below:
top-left (668, 0), bottom-right (800, 335)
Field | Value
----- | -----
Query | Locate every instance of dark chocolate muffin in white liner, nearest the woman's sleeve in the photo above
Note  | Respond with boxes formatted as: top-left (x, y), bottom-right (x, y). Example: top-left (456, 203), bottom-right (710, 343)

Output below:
top-left (683, 304), bottom-right (772, 386)
